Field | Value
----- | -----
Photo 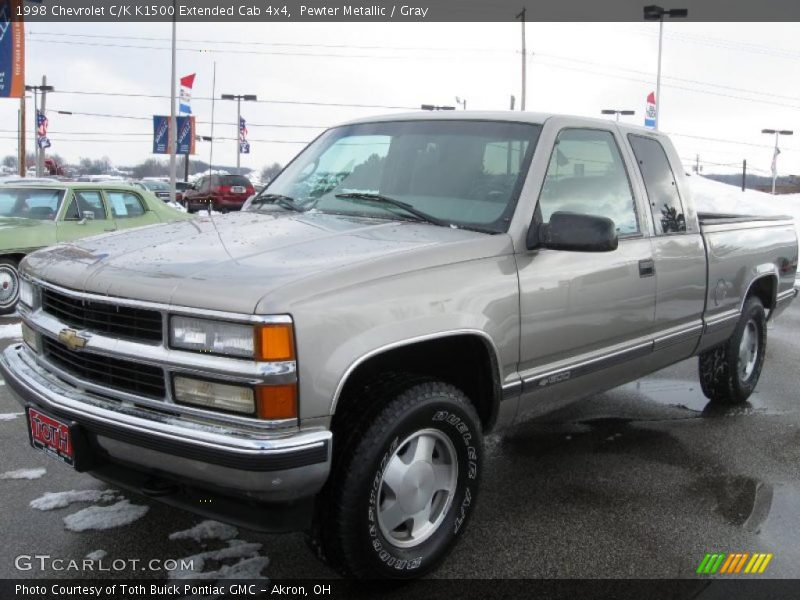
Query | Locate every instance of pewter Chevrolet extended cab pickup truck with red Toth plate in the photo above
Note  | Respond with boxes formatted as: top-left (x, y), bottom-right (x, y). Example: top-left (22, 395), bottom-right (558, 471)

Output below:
top-left (0, 112), bottom-right (798, 578)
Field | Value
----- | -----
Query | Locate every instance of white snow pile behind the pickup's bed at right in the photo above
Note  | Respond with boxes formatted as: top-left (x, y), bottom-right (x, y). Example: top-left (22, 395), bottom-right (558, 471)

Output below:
top-left (686, 175), bottom-right (800, 235)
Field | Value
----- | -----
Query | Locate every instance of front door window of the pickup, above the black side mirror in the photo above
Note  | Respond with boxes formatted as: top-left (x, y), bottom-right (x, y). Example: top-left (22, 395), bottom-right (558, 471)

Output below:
top-left (539, 129), bottom-right (639, 235)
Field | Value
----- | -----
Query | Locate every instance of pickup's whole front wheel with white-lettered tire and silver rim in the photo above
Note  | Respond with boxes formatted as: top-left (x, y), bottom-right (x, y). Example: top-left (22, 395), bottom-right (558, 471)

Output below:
top-left (310, 378), bottom-right (483, 579)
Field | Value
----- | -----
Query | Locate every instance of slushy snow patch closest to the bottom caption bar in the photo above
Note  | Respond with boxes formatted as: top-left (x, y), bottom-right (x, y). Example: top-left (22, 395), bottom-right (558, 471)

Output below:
top-left (169, 540), bottom-right (269, 579)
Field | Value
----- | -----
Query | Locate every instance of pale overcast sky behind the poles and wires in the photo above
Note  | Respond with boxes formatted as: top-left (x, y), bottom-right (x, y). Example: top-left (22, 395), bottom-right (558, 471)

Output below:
top-left (0, 22), bottom-right (800, 174)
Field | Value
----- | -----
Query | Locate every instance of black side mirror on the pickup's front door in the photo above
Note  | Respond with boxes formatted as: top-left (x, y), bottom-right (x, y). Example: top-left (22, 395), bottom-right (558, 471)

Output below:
top-left (527, 212), bottom-right (619, 252)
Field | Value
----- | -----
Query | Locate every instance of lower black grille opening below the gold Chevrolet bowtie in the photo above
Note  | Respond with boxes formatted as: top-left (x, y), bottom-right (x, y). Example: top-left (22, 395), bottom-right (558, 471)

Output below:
top-left (43, 338), bottom-right (166, 399)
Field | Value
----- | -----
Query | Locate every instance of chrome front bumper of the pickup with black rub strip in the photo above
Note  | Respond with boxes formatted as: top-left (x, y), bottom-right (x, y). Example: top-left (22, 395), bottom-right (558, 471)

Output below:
top-left (0, 344), bottom-right (331, 502)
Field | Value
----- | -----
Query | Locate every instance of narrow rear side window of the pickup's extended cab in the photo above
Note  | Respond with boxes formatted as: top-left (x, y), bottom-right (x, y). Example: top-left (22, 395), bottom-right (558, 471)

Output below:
top-left (628, 134), bottom-right (686, 235)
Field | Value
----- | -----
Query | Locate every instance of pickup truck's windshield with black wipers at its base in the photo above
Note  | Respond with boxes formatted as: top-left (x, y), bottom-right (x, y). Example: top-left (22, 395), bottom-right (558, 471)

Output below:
top-left (262, 120), bottom-right (541, 232)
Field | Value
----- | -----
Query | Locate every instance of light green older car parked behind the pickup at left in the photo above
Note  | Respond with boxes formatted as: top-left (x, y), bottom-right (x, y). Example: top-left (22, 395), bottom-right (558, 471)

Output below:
top-left (0, 182), bottom-right (190, 315)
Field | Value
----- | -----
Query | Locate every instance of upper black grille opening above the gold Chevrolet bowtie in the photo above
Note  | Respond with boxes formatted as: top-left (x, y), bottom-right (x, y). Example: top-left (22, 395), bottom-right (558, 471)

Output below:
top-left (42, 288), bottom-right (164, 343)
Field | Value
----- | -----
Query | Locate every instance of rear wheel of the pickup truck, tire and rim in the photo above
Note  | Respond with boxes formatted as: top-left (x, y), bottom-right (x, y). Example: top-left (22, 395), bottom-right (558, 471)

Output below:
top-left (699, 296), bottom-right (767, 405)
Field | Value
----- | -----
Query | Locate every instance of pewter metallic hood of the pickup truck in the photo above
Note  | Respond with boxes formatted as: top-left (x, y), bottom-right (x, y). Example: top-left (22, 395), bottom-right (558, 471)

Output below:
top-left (23, 211), bottom-right (511, 313)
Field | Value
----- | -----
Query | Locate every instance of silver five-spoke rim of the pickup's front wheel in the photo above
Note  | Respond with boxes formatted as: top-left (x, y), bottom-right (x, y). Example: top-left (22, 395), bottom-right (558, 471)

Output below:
top-left (377, 429), bottom-right (458, 548)
